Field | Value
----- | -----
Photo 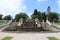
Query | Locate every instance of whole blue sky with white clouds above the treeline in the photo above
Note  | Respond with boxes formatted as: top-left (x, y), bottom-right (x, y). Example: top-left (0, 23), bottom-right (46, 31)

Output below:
top-left (0, 0), bottom-right (60, 18)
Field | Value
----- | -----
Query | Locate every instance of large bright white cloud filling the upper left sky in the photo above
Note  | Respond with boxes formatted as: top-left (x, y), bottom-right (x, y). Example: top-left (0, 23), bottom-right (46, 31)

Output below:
top-left (0, 0), bottom-right (26, 16)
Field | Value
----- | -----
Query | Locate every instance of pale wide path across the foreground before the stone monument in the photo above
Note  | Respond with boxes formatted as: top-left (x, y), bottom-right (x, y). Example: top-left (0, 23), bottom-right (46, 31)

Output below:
top-left (0, 32), bottom-right (60, 40)
